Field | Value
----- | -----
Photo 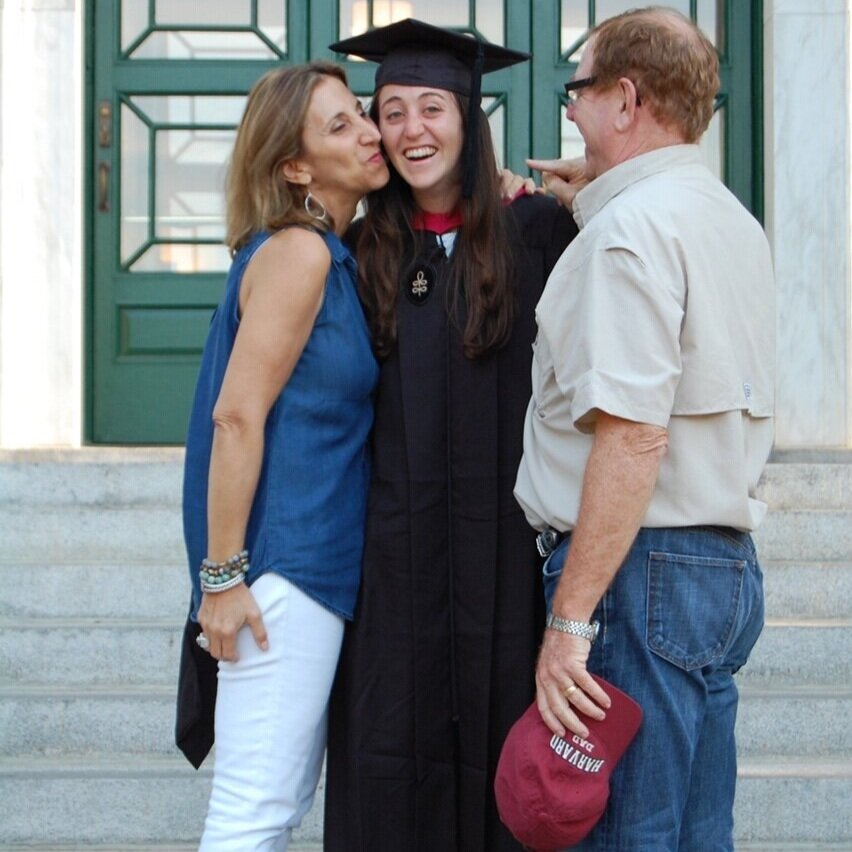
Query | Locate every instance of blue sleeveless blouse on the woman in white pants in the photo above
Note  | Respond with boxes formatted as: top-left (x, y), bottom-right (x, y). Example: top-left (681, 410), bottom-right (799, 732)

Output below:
top-left (183, 233), bottom-right (379, 619)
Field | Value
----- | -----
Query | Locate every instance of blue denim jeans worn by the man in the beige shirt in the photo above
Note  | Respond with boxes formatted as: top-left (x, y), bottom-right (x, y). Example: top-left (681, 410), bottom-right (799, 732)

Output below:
top-left (544, 527), bottom-right (763, 852)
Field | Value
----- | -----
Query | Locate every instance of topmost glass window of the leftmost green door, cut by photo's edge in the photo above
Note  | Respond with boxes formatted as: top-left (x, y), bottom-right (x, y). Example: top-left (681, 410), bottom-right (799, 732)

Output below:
top-left (121, 0), bottom-right (287, 59)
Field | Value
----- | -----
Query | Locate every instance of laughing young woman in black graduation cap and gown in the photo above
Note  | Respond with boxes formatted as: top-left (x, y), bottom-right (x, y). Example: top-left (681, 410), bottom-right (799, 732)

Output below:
top-left (324, 20), bottom-right (577, 852)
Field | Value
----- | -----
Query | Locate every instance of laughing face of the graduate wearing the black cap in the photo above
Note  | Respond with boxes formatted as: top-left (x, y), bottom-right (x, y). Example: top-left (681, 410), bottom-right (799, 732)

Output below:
top-left (377, 84), bottom-right (464, 213)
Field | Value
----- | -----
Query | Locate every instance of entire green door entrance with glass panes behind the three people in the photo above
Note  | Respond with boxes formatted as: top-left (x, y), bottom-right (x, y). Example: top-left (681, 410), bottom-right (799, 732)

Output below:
top-left (86, 0), bottom-right (760, 444)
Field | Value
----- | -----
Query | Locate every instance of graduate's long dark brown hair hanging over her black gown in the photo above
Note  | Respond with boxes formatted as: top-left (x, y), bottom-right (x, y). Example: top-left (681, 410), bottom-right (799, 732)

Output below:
top-left (356, 92), bottom-right (515, 358)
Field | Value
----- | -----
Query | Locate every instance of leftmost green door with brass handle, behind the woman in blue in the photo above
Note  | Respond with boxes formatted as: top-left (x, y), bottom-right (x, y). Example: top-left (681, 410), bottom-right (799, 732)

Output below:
top-left (87, 5), bottom-right (307, 443)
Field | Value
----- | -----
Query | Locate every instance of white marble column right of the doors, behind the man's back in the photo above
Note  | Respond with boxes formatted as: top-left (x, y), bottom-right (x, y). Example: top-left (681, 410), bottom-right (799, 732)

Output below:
top-left (764, 0), bottom-right (852, 448)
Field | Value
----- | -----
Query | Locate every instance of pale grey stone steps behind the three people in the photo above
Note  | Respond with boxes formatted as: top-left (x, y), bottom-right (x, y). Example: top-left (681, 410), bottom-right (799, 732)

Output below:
top-left (0, 448), bottom-right (852, 852)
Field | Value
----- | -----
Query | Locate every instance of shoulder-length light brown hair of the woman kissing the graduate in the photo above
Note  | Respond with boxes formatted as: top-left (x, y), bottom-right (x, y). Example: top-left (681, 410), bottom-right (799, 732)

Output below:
top-left (225, 62), bottom-right (346, 254)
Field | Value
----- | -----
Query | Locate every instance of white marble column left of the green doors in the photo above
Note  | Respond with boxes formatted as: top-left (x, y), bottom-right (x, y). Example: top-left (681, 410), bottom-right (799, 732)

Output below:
top-left (0, 0), bottom-right (84, 447)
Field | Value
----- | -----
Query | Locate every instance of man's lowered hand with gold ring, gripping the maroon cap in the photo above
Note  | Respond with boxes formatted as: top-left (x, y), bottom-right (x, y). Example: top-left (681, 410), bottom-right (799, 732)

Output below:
top-left (535, 630), bottom-right (611, 738)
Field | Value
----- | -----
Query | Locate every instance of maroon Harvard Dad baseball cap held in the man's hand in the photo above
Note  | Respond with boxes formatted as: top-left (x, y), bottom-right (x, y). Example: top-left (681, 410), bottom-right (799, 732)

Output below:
top-left (494, 675), bottom-right (642, 852)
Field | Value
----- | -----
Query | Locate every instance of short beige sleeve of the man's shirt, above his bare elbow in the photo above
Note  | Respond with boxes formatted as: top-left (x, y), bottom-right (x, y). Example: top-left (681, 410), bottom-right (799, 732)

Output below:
top-left (540, 248), bottom-right (686, 433)
